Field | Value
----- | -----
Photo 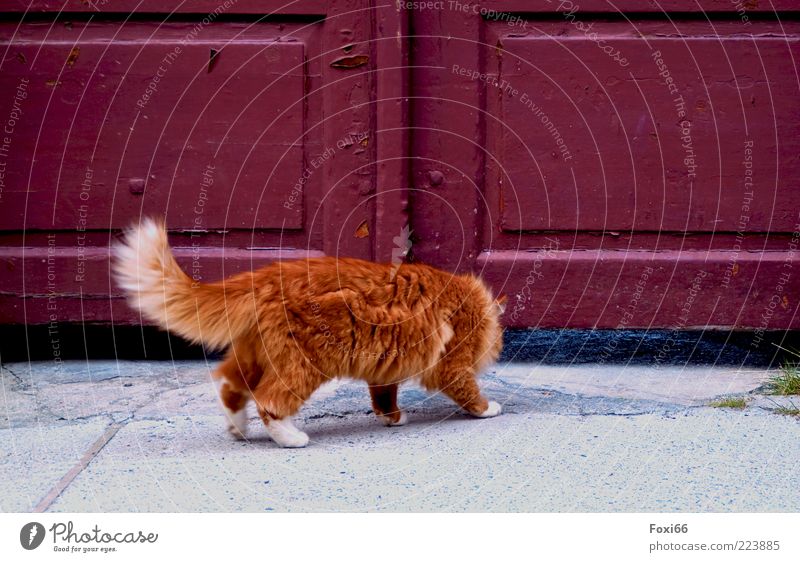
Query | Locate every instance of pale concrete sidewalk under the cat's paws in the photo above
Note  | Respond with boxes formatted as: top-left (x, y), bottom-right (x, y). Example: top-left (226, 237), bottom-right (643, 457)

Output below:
top-left (0, 361), bottom-right (800, 512)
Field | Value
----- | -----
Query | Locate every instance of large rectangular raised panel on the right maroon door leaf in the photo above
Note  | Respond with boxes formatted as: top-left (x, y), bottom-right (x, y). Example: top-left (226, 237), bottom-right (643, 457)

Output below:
top-left (488, 24), bottom-right (800, 232)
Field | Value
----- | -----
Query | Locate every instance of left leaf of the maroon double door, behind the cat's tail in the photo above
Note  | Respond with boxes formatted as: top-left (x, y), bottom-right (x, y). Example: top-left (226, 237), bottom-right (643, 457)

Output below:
top-left (0, 0), bottom-right (407, 324)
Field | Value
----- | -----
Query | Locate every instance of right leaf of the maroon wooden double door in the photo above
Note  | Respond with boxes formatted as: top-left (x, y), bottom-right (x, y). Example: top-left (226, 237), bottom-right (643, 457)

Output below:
top-left (412, 0), bottom-right (800, 330)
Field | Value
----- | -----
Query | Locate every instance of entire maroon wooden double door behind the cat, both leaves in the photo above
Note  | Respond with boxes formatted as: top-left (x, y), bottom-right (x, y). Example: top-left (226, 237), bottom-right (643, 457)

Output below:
top-left (0, 0), bottom-right (800, 330)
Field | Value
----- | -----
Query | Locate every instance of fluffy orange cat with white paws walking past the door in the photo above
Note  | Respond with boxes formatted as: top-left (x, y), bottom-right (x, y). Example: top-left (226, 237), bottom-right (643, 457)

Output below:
top-left (114, 220), bottom-right (505, 447)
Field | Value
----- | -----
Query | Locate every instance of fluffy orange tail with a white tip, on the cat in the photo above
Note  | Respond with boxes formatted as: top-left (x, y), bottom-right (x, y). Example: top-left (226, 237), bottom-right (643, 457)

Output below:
top-left (113, 219), bottom-right (256, 349)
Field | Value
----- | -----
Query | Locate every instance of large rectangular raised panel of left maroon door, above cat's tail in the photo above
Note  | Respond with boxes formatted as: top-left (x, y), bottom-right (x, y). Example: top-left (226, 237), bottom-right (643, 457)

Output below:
top-left (0, 24), bottom-right (305, 230)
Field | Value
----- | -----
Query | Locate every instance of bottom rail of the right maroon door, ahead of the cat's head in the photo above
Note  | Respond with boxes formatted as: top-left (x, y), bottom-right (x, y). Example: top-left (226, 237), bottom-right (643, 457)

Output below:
top-left (477, 249), bottom-right (800, 330)
